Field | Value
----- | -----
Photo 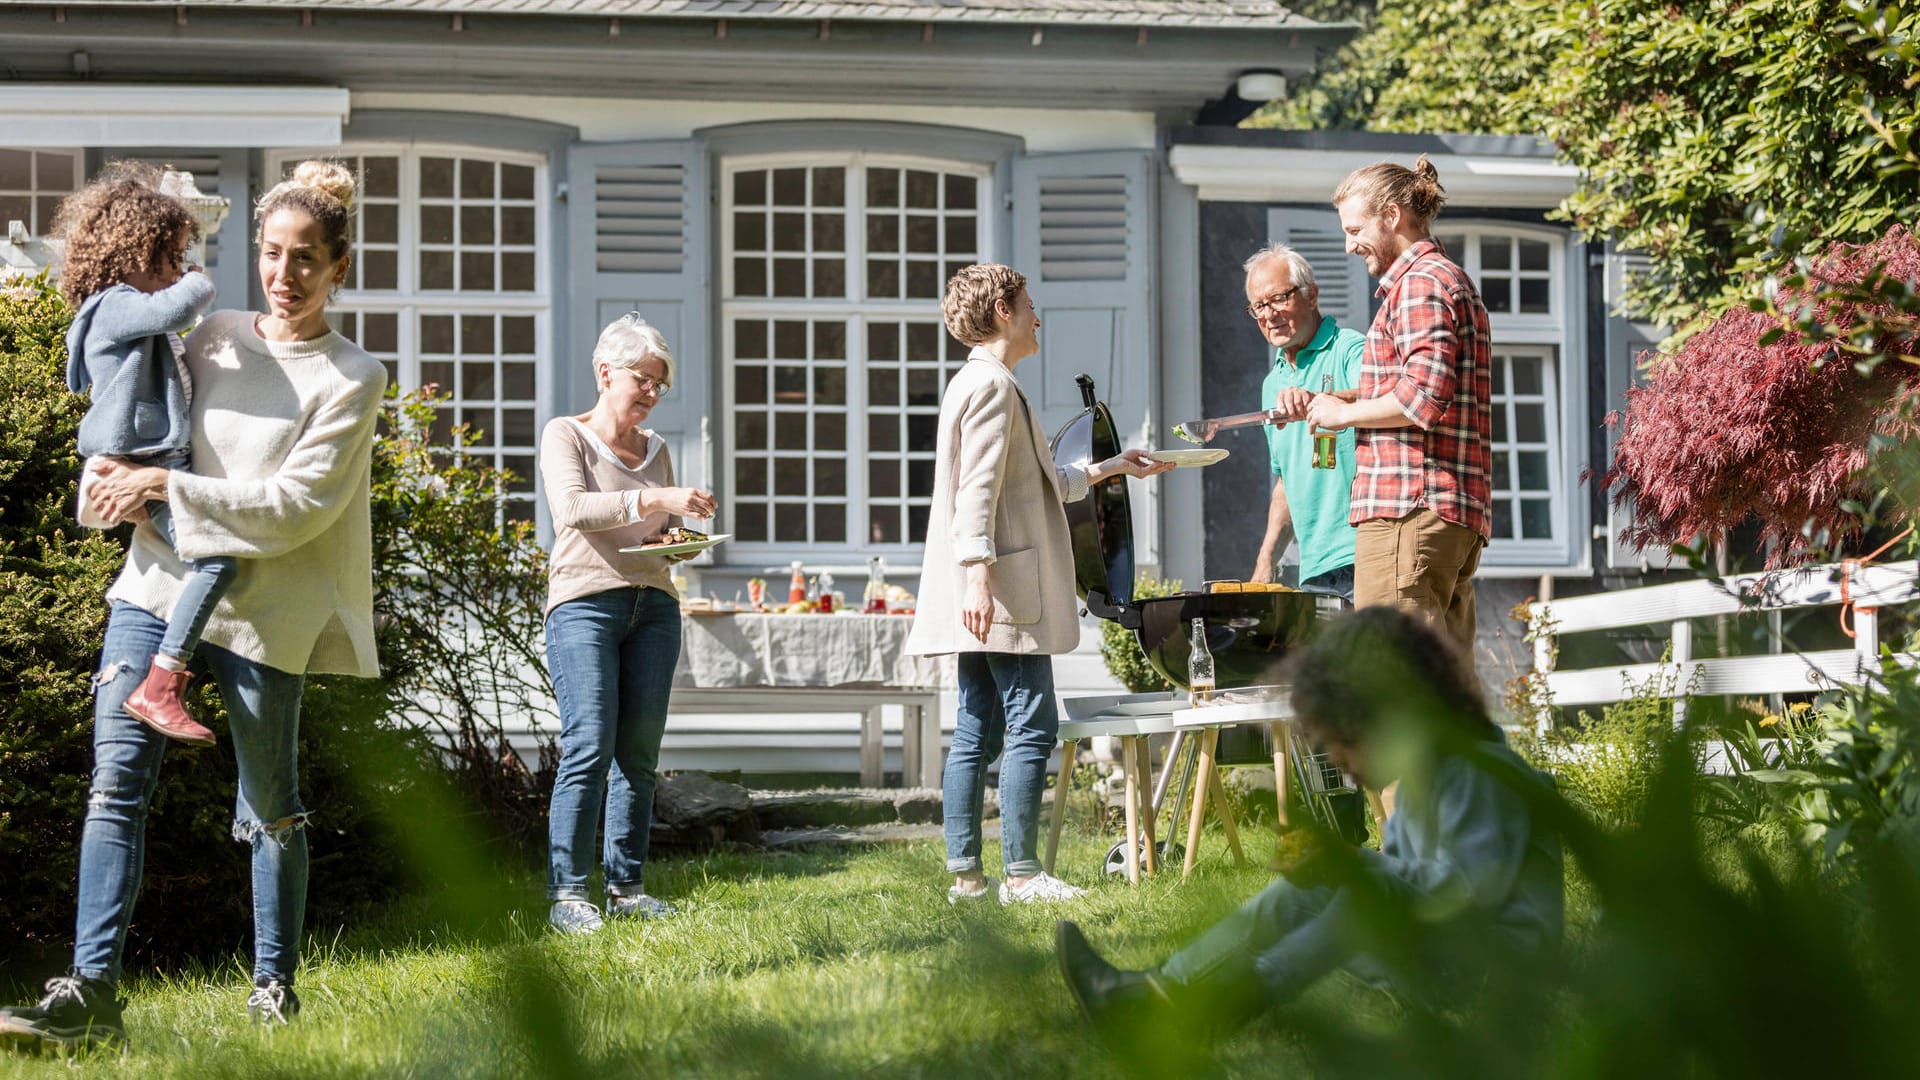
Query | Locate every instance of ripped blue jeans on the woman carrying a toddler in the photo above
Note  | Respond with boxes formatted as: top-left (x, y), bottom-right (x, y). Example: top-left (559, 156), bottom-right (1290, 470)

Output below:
top-left (73, 601), bottom-right (307, 982)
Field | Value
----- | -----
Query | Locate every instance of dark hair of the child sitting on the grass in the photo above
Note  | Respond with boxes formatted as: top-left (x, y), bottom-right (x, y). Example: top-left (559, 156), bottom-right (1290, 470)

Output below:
top-left (1288, 607), bottom-right (1498, 744)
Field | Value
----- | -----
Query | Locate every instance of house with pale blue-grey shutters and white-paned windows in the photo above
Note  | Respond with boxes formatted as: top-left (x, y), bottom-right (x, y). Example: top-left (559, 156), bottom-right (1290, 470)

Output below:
top-left (0, 0), bottom-right (1666, 772)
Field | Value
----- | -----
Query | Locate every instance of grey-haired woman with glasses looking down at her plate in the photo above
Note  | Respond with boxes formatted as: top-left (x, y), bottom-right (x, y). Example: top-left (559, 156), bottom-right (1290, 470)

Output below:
top-left (540, 311), bottom-right (714, 934)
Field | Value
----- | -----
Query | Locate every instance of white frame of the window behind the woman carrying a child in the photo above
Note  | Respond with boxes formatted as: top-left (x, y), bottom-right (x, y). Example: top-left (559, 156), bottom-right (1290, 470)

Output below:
top-left (263, 140), bottom-right (559, 521)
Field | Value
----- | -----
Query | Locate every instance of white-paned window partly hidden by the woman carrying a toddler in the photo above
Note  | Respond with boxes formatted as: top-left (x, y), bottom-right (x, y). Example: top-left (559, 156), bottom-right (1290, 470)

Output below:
top-left (275, 146), bottom-right (551, 521)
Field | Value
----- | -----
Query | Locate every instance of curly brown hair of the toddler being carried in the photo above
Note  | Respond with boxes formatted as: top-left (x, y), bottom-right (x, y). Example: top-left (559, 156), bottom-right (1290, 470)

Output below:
top-left (50, 161), bottom-right (200, 307)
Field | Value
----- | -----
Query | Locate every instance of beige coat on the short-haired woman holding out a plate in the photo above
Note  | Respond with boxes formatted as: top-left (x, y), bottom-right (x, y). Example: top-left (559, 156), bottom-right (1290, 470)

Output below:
top-left (906, 348), bottom-right (1087, 655)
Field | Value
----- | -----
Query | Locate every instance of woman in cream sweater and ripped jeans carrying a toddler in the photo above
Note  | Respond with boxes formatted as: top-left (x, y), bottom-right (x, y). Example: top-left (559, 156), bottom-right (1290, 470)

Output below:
top-left (0, 161), bottom-right (386, 1045)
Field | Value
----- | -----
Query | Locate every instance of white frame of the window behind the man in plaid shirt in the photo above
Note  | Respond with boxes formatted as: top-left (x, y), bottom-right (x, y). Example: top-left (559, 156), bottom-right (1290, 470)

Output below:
top-left (1434, 219), bottom-right (1594, 577)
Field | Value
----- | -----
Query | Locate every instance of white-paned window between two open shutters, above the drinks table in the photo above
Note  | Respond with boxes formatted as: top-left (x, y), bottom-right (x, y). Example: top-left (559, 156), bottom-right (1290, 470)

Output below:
top-left (722, 154), bottom-right (991, 555)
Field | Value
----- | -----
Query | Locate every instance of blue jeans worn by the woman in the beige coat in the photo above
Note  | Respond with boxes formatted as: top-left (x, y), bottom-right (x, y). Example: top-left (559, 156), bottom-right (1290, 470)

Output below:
top-left (941, 653), bottom-right (1060, 876)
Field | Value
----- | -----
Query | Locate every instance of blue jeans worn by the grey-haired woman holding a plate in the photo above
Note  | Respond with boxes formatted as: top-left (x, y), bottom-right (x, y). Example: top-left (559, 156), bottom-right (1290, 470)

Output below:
top-left (547, 588), bottom-right (680, 899)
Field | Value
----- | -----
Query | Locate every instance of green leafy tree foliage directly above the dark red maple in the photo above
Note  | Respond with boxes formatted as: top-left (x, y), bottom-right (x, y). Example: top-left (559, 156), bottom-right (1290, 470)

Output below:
top-left (1542, 0), bottom-right (1920, 327)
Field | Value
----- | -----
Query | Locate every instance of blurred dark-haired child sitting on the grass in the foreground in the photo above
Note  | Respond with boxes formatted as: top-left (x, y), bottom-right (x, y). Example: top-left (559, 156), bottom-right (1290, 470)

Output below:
top-left (1054, 607), bottom-right (1565, 1061)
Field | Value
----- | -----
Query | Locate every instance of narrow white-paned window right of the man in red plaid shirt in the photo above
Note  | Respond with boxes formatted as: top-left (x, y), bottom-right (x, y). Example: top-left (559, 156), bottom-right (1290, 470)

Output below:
top-left (1438, 223), bottom-right (1586, 569)
